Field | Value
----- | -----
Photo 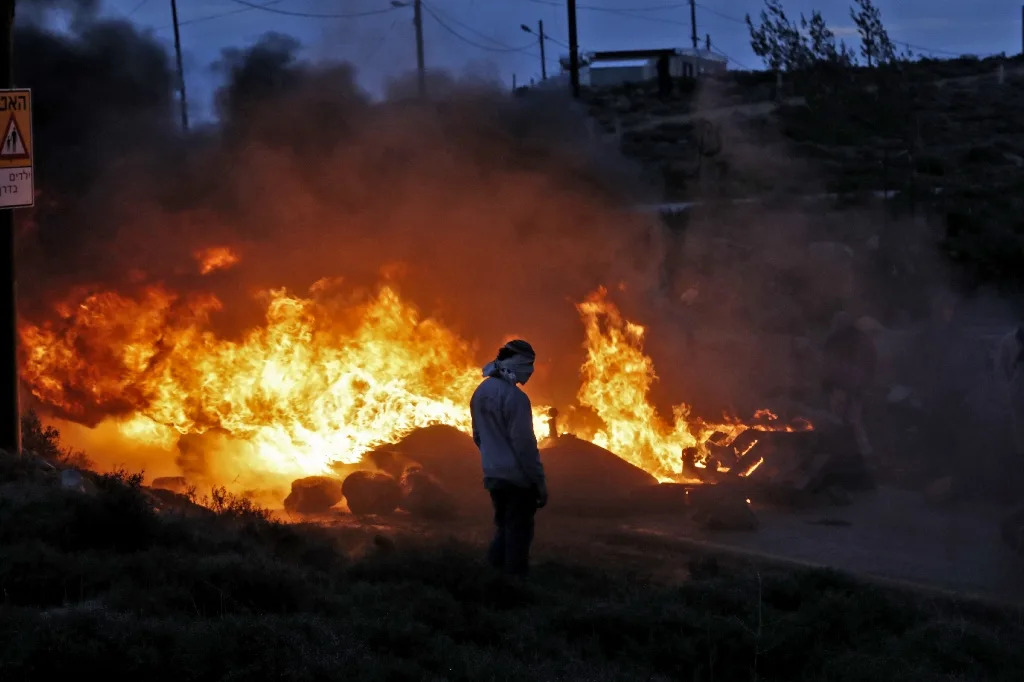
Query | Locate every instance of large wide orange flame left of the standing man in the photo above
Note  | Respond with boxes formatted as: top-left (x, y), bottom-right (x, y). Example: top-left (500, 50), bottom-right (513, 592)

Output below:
top-left (20, 283), bottom-right (561, 485)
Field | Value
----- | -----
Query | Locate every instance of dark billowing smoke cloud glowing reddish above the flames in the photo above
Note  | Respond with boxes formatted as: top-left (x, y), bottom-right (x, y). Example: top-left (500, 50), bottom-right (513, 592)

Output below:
top-left (18, 13), bottom-right (660, 419)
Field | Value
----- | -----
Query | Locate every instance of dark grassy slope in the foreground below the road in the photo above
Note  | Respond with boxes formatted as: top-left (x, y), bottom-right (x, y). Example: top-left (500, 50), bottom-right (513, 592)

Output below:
top-left (0, 446), bottom-right (1024, 682)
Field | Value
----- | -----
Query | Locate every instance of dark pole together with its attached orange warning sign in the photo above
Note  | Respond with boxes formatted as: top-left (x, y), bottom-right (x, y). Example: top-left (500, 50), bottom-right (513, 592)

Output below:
top-left (0, 0), bottom-right (27, 453)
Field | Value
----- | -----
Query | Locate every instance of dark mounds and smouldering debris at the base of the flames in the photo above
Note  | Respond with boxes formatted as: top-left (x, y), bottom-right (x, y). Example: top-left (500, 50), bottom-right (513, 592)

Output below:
top-left (270, 411), bottom-right (873, 530)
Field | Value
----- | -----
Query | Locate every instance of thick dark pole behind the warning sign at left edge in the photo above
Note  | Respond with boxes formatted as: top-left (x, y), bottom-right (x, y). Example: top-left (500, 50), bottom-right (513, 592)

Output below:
top-left (0, 0), bottom-right (22, 453)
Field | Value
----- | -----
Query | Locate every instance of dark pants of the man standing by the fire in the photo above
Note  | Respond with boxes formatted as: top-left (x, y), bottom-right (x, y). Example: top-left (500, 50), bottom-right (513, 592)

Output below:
top-left (487, 484), bottom-right (537, 576)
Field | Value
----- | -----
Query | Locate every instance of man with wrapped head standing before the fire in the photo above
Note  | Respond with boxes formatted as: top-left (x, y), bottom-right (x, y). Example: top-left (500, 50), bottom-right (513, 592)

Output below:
top-left (470, 340), bottom-right (548, 576)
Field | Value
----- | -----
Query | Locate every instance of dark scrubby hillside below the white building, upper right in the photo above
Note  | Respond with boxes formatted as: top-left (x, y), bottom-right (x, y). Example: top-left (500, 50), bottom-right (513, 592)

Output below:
top-left (585, 57), bottom-right (1024, 289)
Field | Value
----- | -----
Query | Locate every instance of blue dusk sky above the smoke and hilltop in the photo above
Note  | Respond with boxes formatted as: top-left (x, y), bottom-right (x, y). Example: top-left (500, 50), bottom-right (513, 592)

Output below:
top-left (90, 0), bottom-right (1021, 118)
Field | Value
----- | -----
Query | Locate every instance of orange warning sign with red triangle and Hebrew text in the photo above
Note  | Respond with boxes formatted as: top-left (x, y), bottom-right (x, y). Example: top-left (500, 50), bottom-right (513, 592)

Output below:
top-left (0, 88), bottom-right (36, 208)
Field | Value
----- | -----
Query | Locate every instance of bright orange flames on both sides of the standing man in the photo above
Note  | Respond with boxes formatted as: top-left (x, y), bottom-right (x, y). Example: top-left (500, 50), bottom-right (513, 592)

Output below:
top-left (14, 282), bottom-right (798, 486)
